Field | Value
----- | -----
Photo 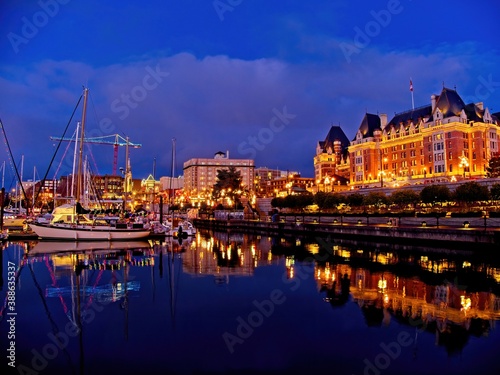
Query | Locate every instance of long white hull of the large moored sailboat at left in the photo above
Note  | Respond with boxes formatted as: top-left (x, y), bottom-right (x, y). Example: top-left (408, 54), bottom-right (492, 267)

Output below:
top-left (30, 223), bottom-right (150, 241)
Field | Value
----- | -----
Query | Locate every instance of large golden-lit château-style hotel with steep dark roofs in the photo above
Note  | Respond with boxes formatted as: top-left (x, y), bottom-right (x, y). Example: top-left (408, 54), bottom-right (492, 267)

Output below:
top-left (314, 88), bottom-right (500, 187)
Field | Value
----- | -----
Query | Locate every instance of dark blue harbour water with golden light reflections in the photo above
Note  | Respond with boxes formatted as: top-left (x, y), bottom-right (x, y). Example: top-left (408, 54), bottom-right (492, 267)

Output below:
top-left (0, 231), bottom-right (500, 375)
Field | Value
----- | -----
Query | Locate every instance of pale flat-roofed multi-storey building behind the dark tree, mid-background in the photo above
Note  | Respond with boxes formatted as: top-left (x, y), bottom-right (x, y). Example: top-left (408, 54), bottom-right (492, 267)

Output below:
top-left (183, 152), bottom-right (255, 203)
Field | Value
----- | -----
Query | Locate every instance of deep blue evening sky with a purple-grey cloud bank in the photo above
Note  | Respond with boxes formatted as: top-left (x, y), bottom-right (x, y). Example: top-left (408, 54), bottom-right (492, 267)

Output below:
top-left (0, 0), bottom-right (500, 187)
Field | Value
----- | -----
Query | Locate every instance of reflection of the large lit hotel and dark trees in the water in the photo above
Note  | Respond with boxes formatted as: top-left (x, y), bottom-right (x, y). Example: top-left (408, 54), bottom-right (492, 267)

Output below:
top-left (309, 241), bottom-right (500, 354)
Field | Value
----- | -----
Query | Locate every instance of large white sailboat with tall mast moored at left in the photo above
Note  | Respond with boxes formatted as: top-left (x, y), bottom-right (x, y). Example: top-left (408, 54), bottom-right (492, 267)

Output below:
top-left (29, 88), bottom-right (151, 241)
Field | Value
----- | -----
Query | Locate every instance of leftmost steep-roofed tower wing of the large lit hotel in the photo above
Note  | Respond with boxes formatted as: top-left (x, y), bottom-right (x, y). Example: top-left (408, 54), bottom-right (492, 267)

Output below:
top-left (314, 126), bottom-right (350, 191)
